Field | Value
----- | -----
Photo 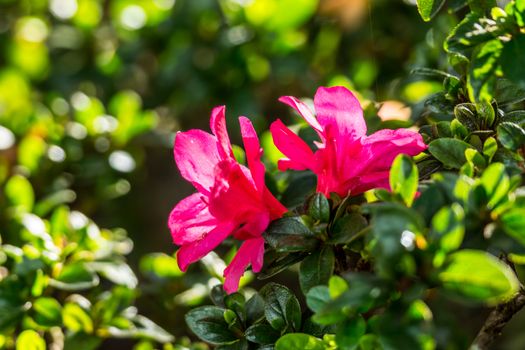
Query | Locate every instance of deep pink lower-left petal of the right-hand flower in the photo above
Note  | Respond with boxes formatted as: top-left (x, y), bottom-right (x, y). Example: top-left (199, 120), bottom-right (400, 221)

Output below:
top-left (270, 119), bottom-right (315, 171)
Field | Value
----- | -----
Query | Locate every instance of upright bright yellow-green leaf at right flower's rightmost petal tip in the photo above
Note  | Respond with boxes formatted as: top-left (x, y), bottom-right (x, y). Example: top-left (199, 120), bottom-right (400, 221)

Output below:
top-left (390, 154), bottom-right (419, 207)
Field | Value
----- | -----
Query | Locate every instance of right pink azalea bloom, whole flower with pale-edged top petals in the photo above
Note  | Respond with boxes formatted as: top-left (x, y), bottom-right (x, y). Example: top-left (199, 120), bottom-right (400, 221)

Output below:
top-left (270, 86), bottom-right (427, 197)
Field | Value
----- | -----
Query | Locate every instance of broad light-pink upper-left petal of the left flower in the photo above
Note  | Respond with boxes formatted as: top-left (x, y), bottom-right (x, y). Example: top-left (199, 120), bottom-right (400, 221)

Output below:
top-left (174, 130), bottom-right (220, 193)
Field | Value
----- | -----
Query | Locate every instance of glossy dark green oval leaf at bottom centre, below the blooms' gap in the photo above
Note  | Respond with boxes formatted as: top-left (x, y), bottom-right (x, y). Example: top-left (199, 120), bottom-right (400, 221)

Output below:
top-left (260, 283), bottom-right (301, 332)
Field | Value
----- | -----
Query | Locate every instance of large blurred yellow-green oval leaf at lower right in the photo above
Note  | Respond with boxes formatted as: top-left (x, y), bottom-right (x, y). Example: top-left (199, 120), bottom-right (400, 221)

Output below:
top-left (438, 249), bottom-right (519, 305)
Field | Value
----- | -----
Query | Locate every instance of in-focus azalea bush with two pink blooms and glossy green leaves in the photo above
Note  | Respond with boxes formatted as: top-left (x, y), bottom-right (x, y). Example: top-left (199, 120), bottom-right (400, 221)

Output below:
top-left (169, 1), bottom-right (525, 350)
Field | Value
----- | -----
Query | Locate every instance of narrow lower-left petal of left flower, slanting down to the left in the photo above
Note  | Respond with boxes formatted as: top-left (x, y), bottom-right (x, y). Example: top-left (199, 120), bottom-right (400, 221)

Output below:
top-left (177, 222), bottom-right (235, 271)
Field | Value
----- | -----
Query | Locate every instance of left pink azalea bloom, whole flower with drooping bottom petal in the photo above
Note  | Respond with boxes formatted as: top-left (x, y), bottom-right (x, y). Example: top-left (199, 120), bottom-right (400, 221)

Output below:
top-left (168, 106), bottom-right (286, 293)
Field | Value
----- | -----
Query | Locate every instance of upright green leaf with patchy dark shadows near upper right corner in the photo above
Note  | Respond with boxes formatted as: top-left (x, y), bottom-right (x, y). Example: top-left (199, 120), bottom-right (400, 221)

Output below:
top-left (467, 39), bottom-right (503, 102)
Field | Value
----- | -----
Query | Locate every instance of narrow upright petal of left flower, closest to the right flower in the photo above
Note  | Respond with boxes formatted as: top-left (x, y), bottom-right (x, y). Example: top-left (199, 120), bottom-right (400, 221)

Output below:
top-left (239, 117), bottom-right (265, 193)
